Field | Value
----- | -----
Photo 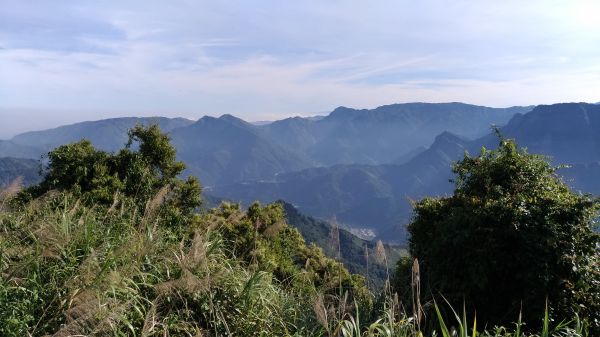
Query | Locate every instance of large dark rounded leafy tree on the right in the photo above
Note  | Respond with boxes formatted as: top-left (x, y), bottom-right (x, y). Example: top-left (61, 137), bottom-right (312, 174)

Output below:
top-left (398, 138), bottom-right (600, 332)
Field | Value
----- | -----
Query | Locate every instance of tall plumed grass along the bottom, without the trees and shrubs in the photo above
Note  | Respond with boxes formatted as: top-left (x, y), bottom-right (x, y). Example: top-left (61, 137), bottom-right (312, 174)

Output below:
top-left (0, 185), bottom-right (588, 337)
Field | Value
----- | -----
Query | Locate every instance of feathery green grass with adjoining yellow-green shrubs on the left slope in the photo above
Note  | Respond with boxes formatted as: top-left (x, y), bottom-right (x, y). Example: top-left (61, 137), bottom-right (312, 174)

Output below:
top-left (0, 192), bottom-right (370, 336)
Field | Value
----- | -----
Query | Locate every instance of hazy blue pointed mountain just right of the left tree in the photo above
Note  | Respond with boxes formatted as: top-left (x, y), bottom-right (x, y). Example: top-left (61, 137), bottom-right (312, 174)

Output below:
top-left (171, 115), bottom-right (314, 186)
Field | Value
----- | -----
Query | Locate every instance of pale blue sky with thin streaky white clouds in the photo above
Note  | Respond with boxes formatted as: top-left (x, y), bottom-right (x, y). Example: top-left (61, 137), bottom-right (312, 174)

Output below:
top-left (0, 0), bottom-right (600, 139)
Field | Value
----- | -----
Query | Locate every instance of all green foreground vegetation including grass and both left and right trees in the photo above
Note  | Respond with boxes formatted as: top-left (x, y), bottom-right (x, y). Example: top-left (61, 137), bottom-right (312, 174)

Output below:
top-left (0, 126), bottom-right (598, 337)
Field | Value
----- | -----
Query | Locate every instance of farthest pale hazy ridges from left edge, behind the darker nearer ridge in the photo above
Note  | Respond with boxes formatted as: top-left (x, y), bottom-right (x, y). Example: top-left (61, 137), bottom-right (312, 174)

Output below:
top-left (0, 103), bottom-right (531, 187)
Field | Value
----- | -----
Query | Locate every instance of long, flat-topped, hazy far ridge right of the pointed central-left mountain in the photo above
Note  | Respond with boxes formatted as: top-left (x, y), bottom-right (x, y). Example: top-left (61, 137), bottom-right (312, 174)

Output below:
top-left (265, 103), bottom-right (532, 166)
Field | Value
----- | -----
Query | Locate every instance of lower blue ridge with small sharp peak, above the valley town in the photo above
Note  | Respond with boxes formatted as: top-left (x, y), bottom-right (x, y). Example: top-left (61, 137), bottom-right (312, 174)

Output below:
top-left (210, 132), bottom-right (469, 242)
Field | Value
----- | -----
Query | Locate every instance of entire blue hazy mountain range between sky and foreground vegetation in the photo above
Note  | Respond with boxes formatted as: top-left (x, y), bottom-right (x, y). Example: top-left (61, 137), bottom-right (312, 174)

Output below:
top-left (0, 103), bottom-right (600, 243)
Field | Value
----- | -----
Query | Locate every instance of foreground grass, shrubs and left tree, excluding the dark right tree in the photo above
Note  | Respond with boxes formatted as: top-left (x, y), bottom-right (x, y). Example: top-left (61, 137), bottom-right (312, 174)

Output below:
top-left (0, 127), bottom-right (593, 336)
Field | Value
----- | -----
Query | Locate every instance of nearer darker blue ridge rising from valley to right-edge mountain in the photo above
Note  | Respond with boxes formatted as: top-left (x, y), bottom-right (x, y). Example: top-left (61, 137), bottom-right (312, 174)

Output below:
top-left (211, 103), bottom-right (600, 242)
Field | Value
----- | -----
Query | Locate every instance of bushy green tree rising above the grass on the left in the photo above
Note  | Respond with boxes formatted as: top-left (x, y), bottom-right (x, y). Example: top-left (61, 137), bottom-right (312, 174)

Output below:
top-left (17, 125), bottom-right (200, 220)
